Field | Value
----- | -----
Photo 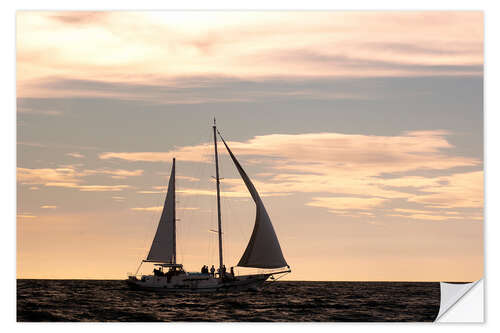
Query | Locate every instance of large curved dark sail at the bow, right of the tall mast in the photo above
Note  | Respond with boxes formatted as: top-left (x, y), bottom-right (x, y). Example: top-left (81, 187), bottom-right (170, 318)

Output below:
top-left (219, 133), bottom-right (288, 268)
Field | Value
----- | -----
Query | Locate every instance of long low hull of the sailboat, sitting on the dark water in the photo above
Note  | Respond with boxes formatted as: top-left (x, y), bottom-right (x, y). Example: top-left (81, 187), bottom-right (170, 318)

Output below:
top-left (126, 274), bottom-right (271, 292)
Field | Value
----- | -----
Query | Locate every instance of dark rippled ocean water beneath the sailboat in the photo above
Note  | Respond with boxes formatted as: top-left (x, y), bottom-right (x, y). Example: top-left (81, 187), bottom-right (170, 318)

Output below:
top-left (17, 279), bottom-right (440, 322)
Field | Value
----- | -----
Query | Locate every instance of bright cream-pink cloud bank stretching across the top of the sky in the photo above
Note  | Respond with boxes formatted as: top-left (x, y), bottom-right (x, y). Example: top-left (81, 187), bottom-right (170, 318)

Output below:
top-left (17, 12), bottom-right (483, 102)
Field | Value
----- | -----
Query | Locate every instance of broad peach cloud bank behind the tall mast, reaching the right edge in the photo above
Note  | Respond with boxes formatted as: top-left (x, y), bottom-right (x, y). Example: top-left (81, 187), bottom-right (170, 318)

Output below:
top-left (100, 130), bottom-right (483, 219)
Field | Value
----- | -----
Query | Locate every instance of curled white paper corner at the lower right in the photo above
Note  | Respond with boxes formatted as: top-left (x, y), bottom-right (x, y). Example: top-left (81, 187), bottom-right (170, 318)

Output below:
top-left (435, 279), bottom-right (484, 323)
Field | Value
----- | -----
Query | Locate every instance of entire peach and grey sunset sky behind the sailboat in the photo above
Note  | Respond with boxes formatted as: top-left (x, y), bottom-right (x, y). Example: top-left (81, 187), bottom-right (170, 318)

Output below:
top-left (16, 11), bottom-right (484, 281)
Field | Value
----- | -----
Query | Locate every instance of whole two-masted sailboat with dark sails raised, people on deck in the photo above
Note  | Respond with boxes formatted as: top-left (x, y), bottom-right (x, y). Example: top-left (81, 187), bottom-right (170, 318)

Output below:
top-left (126, 118), bottom-right (291, 291)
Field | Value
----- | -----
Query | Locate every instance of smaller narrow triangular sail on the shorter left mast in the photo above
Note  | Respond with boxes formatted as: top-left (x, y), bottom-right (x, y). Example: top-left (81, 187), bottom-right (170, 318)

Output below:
top-left (146, 158), bottom-right (176, 264)
